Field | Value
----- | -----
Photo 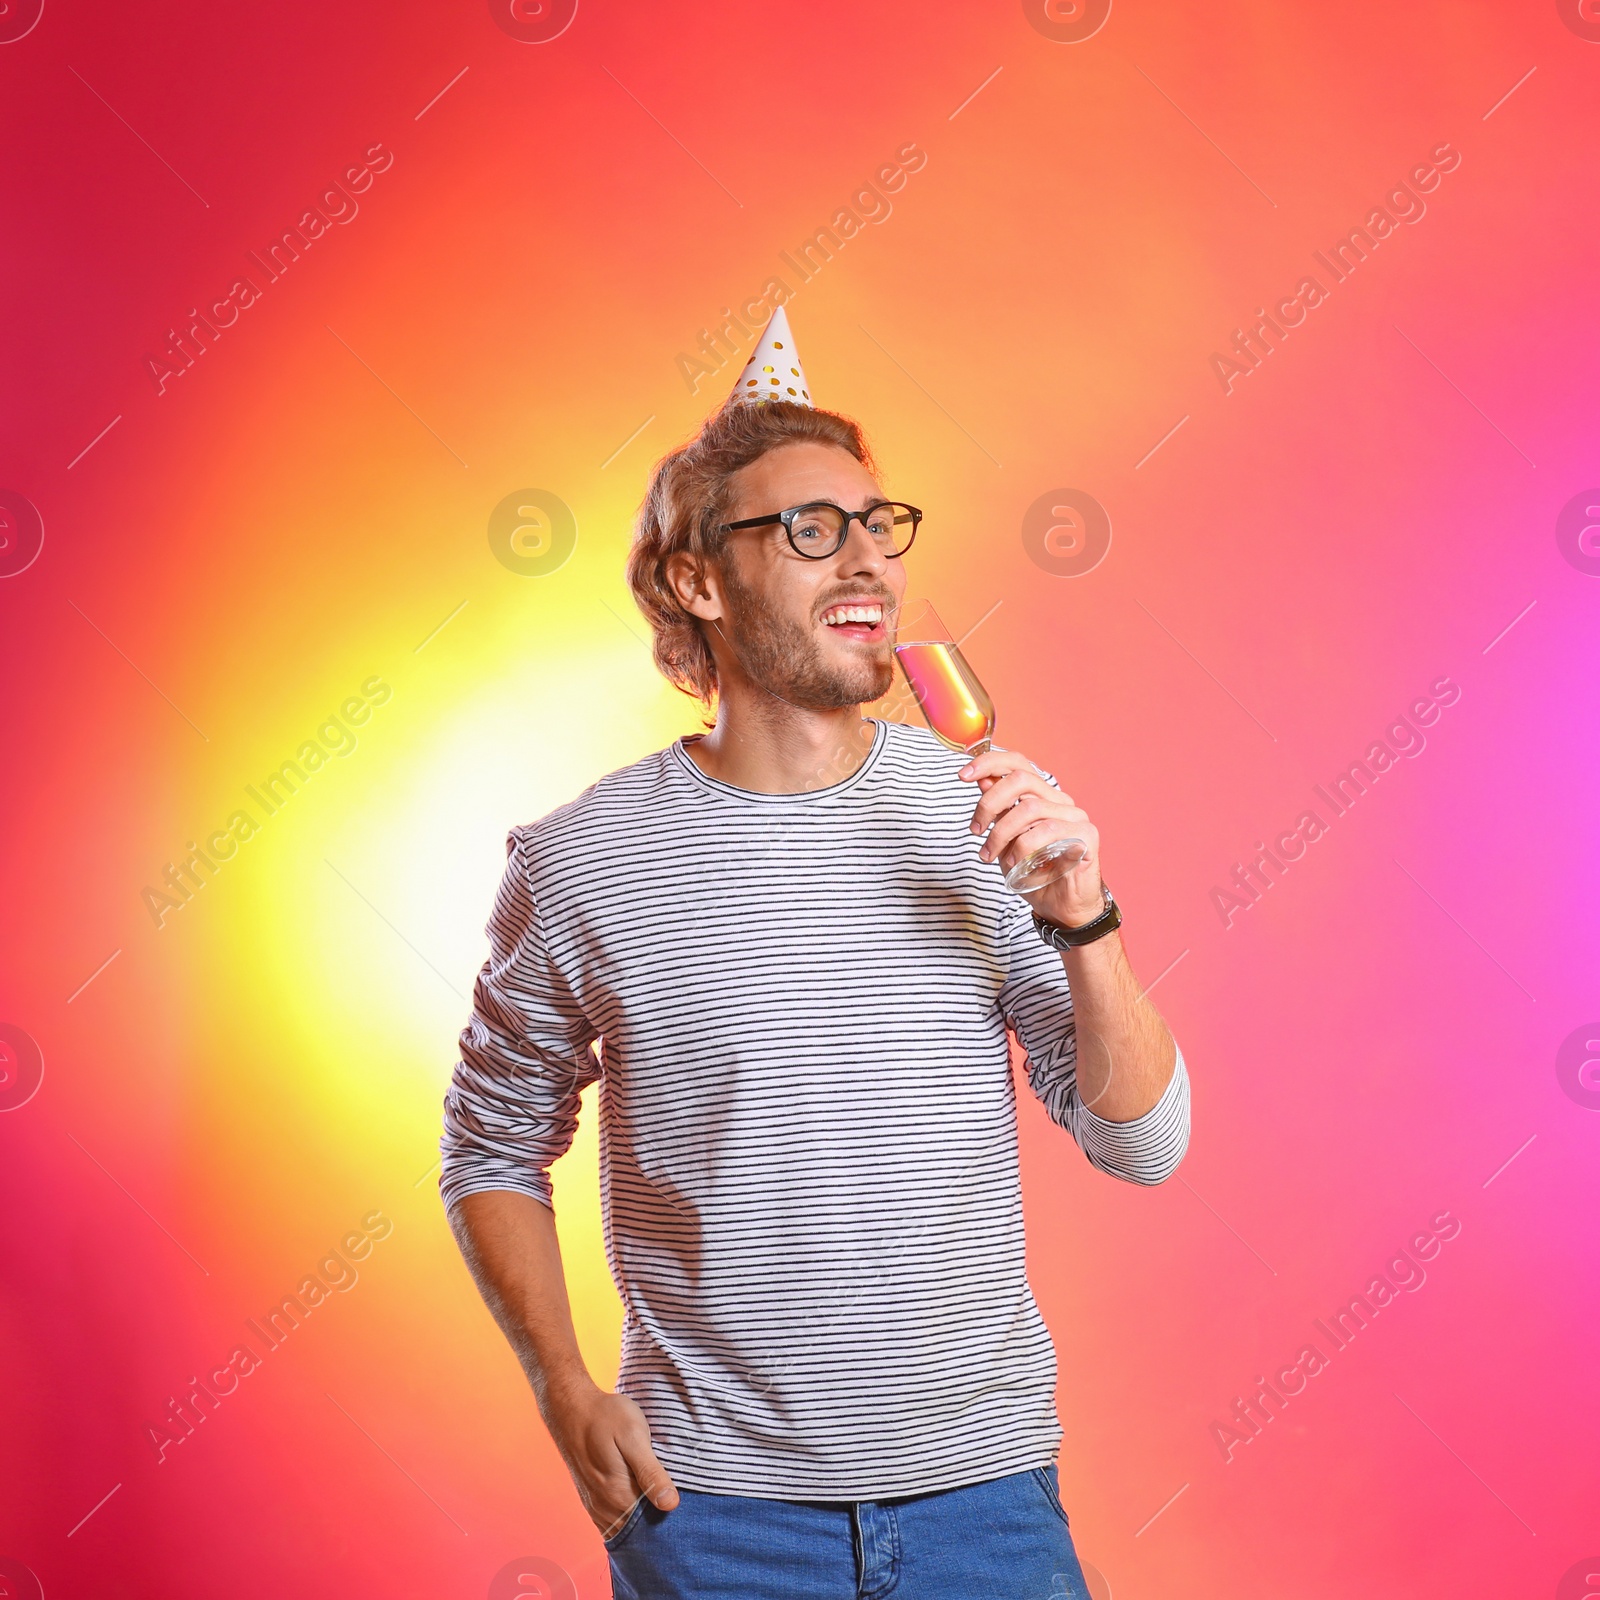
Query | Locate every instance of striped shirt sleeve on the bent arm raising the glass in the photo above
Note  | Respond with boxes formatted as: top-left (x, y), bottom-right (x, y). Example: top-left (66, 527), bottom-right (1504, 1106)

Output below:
top-left (1000, 902), bottom-right (1189, 1184)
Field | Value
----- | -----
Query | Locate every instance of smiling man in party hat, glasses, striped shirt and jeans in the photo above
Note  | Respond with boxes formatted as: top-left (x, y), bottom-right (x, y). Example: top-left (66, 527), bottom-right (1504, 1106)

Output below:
top-left (442, 310), bottom-right (1189, 1600)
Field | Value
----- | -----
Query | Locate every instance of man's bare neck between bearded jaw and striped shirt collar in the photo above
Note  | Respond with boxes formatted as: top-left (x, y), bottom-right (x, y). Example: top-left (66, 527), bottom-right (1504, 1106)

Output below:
top-left (685, 683), bottom-right (875, 795)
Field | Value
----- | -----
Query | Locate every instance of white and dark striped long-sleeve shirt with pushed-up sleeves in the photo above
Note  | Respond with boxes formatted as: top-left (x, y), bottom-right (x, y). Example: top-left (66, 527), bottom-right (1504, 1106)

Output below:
top-left (440, 722), bottom-right (1189, 1501)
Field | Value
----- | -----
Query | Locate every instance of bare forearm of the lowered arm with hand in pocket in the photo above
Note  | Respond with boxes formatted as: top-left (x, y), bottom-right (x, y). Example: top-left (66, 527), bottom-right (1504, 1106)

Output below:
top-left (450, 1189), bottom-right (595, 1422)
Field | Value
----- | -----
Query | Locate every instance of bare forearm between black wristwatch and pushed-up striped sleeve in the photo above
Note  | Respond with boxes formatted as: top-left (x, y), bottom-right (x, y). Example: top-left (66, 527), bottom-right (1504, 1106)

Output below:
top-left (1061, 933), bottom-right (1178, 1122)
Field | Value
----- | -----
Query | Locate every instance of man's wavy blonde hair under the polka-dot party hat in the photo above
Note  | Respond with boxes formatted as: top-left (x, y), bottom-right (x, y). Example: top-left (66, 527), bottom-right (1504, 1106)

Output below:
top-left (627, 400), bottom-right (875, 707)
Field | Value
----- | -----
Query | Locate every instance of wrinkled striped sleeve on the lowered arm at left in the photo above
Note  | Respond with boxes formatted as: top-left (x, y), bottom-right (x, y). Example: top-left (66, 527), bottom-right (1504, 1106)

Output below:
top-left (438, 829), bottom-right (600, 1208)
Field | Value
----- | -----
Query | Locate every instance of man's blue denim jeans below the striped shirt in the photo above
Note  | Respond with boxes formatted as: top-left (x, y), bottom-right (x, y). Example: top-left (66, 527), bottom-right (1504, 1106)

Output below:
top-left (606, 1467), bottom-right (1090, 1600)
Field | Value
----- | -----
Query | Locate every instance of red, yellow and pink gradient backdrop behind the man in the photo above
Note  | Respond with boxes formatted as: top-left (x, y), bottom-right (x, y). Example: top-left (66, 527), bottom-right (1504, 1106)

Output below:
top-left (0, 0), bottom-right (1600, 1600)
